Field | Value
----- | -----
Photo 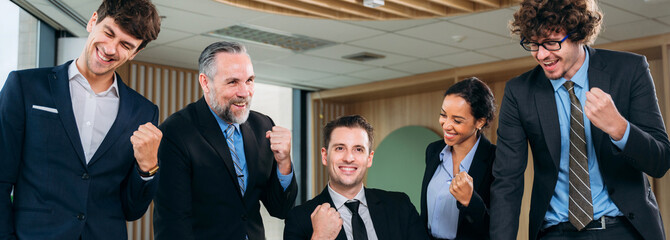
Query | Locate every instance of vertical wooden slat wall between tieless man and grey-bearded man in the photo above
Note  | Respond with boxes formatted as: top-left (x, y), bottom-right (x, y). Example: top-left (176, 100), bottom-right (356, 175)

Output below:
top-left (117, 61), bottom-right (202, 240)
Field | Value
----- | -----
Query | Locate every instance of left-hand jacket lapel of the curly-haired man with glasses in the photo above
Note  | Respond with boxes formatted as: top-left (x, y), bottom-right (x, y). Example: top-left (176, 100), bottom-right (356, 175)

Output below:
top-left (530, 73), bottom-right (561, 169)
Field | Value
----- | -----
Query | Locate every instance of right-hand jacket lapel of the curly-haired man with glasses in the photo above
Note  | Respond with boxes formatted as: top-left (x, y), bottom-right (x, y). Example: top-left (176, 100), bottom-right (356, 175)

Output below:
top-left (586, 47), bottom-right (615, 156)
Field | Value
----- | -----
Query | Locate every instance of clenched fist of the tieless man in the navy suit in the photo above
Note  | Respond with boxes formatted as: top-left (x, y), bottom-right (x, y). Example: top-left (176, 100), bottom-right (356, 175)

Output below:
top-left (130, 122), bottom-right (163, 172)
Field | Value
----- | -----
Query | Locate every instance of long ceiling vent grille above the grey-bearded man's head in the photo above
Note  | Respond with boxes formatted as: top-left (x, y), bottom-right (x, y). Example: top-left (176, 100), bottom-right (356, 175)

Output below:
top-left (207, 25), bottom-right (337, 52)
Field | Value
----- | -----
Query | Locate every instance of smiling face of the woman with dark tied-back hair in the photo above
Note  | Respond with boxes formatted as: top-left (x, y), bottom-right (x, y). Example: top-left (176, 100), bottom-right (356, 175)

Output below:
top-left (439, 94), bottom-right (486, 148)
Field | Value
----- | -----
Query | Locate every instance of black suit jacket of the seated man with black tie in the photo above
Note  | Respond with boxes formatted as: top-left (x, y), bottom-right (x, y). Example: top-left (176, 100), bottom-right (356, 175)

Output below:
top-left (284, 187), bottom-right (428, 240)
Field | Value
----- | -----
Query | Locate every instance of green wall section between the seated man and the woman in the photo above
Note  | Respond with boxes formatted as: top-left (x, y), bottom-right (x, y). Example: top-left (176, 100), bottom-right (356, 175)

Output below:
top-left (366, 126), bottom-right (441, 211)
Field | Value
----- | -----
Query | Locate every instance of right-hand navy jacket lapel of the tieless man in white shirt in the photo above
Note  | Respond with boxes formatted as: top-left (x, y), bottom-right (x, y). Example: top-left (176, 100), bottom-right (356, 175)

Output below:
top-left (88, 73), bottom-right (136, 166)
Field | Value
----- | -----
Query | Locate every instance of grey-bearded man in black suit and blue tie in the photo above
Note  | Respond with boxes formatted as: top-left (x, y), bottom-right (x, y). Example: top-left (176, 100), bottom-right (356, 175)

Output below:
top-left (154, 42), bottom-right (297, 240)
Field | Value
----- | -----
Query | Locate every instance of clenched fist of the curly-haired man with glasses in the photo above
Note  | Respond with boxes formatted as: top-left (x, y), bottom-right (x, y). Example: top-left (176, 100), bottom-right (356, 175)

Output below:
top-left (584, 87), bottom-right (628, 141)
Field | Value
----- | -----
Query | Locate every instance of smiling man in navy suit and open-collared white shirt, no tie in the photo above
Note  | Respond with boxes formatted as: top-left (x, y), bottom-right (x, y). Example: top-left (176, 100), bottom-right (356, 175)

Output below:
top-left (0, 0), bottom-right (161, 240)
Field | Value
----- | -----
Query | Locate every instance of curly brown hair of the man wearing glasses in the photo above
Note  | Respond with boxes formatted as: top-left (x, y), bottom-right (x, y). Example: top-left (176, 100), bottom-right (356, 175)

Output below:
top-left (510, 0), bottom-right (603, 45)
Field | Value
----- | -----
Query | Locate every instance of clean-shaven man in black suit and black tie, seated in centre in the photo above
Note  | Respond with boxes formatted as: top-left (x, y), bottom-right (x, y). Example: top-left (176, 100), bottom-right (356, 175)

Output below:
top-left (284, 115), bottom-right (428, 240)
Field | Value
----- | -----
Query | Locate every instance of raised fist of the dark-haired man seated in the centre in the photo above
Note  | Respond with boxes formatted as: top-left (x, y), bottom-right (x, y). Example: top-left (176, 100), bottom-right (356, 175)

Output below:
top-left (310, 203), bottom-right (342, 239)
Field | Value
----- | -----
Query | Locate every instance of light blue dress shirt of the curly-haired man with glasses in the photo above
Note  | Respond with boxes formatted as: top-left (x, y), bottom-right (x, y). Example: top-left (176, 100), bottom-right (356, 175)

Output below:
top-left (544, 48), bottom-right (630, 228)
